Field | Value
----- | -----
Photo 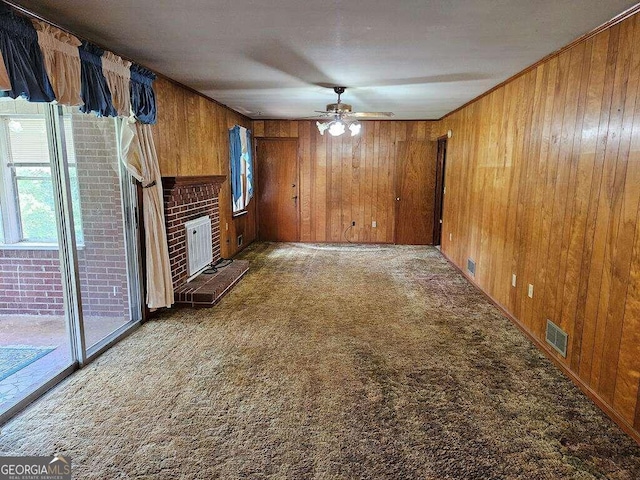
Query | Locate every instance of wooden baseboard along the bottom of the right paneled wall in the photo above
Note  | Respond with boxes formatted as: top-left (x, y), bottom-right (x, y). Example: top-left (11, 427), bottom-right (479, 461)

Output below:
top-left (440, 251), bottom-right (640, 445)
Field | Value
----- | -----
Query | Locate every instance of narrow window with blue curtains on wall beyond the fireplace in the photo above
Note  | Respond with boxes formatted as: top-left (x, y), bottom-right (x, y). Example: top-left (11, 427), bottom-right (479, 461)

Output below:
top-left (229, 125), bottom-right (253, 214)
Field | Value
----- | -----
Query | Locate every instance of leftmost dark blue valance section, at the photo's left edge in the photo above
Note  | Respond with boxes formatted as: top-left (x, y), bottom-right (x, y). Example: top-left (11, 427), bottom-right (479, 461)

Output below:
top-left (0, 5), bottom-right (56, 102)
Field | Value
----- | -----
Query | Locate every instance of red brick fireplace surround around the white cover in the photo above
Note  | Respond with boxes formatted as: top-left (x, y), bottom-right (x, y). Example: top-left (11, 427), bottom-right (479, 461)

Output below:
top-left (164, 182), bottom-right (220, 288)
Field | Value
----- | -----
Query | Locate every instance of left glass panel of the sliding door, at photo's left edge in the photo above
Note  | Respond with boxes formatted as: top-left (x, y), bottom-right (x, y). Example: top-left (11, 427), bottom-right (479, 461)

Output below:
top-left (0, 99), bottom-right (75, 414)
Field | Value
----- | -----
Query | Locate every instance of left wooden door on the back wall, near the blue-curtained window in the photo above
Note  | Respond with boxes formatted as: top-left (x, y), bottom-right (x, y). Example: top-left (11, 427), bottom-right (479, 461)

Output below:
top-left (256, 138), bottom-right (300, 242)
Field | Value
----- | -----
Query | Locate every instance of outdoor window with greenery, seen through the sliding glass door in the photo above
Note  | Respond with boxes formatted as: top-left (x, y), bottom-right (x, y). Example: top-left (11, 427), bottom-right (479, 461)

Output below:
top-left (0, 107), bottom-right (83, 244)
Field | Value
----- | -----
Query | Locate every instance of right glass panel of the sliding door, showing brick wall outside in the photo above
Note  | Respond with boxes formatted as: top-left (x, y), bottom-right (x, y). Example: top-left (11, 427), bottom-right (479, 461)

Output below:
top-left (62, 108), bottom-right (139, 352)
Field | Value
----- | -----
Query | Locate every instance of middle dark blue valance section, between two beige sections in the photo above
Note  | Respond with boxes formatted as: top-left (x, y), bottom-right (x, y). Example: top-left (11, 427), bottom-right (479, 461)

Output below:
top-left (78, 41), bottom-right (118, 117)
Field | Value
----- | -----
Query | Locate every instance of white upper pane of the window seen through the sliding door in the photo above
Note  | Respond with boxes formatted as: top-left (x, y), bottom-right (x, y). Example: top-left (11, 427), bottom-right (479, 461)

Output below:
top-left (4, 116), bottom-right (49, 163)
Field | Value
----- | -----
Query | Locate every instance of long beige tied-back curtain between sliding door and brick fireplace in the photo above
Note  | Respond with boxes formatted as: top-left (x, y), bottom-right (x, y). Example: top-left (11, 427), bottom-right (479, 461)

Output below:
top-left (120, 117), bottom-right (173, 308)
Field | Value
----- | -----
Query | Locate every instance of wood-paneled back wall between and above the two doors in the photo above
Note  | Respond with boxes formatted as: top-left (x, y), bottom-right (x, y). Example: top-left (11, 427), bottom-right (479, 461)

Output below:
top-left (253, 120), bottom-right (435, 243)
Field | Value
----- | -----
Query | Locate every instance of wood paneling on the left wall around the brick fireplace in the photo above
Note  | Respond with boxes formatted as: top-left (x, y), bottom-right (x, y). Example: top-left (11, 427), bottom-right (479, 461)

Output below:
top-left (154, 79), bottom-right (256, 258)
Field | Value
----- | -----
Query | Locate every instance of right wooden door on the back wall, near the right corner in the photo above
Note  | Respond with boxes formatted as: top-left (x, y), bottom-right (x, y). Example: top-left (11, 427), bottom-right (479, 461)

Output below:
top-left (395, 140), bottom-right (436, 245)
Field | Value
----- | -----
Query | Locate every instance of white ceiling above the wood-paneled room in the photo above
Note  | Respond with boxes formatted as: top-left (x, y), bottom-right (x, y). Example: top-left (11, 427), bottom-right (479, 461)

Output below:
top-left (15, 0), bottom-right (636, 119)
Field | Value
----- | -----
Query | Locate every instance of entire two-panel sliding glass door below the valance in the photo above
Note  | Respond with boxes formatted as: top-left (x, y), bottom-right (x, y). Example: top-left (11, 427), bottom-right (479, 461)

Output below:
top-left (0, 99), bottom-right (141, 420)
